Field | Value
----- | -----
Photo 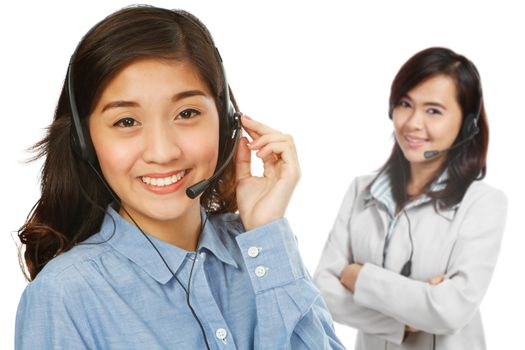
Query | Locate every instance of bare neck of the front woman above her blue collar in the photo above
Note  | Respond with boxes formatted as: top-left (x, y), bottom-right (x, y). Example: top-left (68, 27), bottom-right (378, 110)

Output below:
top-left (119, 205), bottom-right (201, 251)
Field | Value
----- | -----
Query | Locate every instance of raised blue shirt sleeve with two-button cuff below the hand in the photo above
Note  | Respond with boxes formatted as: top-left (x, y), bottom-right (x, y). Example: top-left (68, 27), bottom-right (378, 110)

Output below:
top-left (236, 219), bottom-right (344, 350)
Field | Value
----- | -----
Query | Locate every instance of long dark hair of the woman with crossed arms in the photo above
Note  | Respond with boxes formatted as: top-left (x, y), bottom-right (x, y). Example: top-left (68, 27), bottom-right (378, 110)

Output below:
top-left (381, 47), bottom-right (489, 208)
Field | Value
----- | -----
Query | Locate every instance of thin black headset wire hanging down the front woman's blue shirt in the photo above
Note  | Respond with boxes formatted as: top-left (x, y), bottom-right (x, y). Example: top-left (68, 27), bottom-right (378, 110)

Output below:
top-left (86, 162), bottom-right (210, 350)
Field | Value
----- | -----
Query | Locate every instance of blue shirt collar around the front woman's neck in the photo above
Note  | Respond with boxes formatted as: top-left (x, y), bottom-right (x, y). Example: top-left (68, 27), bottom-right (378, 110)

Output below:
top-left (100, 206), bottom-right (237, 284)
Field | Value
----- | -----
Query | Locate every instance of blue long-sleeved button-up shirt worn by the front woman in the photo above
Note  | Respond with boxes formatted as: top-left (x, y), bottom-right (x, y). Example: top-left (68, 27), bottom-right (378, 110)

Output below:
top-left (15, 207), bottom-right (343, 350)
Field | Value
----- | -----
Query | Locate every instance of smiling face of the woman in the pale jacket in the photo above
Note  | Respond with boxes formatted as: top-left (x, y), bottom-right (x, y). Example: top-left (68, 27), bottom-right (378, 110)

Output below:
top-left (393, 75), bottom-right (462, 166)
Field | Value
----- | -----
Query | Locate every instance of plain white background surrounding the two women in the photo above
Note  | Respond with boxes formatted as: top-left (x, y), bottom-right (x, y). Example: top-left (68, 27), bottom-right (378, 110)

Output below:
top-left (0, 0), bottom-right (525, 349)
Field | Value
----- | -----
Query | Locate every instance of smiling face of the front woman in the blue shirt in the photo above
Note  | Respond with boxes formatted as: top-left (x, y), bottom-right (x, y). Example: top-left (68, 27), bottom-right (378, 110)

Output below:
top-left (89, 59), bottom-right (219, 232)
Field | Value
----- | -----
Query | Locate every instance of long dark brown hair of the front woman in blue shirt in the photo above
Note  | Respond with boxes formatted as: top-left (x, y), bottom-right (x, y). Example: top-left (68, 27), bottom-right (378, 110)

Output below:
top-left (18, 6), bottom-right (237, 280)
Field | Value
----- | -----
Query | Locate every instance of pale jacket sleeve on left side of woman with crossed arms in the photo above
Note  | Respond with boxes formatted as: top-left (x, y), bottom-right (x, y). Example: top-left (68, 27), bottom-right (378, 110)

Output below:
top-left (314, 180), bottom-right (405, 344)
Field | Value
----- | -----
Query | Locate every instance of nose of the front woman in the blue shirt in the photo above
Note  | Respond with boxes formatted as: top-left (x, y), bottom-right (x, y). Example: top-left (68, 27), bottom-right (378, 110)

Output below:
top-left (142, 125), bottom-right (182, 164)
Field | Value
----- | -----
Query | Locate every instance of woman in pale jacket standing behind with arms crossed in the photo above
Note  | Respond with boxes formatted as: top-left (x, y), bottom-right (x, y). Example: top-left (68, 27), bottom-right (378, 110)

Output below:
top-left (314, 48), bottom-right (507, 350)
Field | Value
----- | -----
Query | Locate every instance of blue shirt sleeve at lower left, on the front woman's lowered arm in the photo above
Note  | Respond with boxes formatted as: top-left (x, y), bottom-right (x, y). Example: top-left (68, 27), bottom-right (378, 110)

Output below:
top-left (15, 278), bottom-right (90, 350)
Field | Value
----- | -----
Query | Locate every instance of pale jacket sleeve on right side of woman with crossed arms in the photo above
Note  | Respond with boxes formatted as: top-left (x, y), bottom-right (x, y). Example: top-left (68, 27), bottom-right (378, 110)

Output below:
top-left (354, 190), bottom-right (507, 334)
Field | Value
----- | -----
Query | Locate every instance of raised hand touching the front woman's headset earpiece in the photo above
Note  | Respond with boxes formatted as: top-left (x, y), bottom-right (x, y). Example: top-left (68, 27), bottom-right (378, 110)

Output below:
top-left (235, 116), bottom-right (300, 231)
